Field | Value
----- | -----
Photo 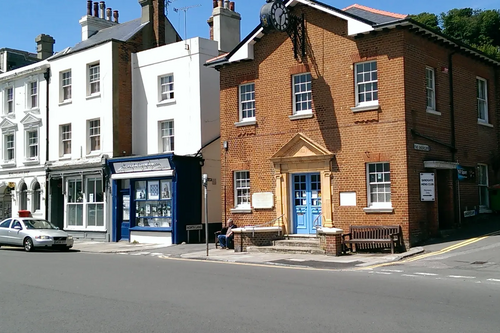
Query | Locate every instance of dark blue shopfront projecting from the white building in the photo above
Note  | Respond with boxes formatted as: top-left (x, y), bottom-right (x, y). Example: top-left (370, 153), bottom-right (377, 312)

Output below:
top-left (108, 154), bottom-right (203, 244)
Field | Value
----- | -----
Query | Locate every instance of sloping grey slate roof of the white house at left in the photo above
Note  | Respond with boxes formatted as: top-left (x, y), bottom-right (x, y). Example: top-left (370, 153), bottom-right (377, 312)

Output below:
top-left (50, 18), bottom-right (148, 60)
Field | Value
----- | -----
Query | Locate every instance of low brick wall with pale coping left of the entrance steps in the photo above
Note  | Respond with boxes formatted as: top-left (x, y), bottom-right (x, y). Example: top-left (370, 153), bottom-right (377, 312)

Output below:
top-left (233, 227), bottom-right (283, 252)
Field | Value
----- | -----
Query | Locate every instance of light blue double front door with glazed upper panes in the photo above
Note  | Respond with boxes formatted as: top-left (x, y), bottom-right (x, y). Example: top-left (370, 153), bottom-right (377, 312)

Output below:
top-left (292, 173), bottom-right (321, 234)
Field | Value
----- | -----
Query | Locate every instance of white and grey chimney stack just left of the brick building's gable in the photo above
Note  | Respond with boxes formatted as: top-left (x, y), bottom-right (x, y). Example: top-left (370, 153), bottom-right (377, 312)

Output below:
top-left (207, 0), bottom-right (241, 52)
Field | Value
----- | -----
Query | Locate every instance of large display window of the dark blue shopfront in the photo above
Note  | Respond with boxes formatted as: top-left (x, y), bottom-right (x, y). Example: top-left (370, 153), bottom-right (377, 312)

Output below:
top-left (134, 179), bottom-right (173, 228)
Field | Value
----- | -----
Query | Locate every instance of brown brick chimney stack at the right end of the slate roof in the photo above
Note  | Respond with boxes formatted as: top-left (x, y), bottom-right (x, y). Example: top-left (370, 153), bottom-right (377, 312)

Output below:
top-left (139, 0), bottom-right (166, 49)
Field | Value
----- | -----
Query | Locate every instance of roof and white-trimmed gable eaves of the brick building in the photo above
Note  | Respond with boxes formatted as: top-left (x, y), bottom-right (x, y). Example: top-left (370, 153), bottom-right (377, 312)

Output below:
top-left (205, 0), bottom-right (500, 67)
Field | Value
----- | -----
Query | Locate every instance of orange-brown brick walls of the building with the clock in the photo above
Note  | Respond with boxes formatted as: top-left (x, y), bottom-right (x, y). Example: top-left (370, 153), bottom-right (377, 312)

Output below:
top-left (219, 6), bottom-right (500, 247)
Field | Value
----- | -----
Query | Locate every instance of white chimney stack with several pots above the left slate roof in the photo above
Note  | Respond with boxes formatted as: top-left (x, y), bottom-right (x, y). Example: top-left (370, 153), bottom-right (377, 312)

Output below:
top-left (80, 0), bottom-right (118, 41)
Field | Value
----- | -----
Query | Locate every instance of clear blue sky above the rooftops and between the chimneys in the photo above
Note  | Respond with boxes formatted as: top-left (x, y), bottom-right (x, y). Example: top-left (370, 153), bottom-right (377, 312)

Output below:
top-left (0, 0), bottom-right (500, 53)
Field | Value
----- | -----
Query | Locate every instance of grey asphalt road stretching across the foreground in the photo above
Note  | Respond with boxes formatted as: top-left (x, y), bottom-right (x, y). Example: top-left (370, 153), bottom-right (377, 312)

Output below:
top-left (0, 248), bottom-right (500, 333)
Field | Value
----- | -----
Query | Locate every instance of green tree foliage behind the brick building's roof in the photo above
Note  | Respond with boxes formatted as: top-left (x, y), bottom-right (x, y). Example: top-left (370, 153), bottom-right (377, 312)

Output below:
top-left (410, 8), bottom-right (500, 60)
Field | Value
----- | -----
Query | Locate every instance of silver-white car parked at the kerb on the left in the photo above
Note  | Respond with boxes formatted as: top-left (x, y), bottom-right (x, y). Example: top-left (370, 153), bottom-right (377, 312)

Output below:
top-left (0, 217), bottom-right (73, 252)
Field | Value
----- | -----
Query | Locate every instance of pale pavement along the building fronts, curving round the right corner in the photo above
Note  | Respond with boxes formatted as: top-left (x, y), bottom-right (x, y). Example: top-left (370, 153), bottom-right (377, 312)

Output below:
top-left (72, 215), bottom-right (500, 269)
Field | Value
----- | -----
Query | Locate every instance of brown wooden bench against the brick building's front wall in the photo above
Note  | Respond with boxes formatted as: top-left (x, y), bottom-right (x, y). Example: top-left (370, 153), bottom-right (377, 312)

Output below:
top-left (342, 225), bottom-right (403, 253)
